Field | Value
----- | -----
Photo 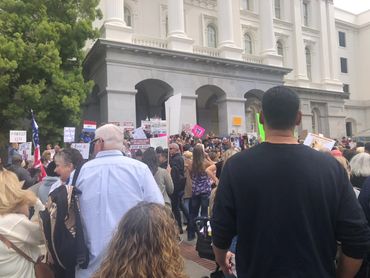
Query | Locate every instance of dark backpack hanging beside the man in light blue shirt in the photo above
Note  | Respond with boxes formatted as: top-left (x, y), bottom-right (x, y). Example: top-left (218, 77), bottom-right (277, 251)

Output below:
top-left (39, 167), bottom-right (89, 271)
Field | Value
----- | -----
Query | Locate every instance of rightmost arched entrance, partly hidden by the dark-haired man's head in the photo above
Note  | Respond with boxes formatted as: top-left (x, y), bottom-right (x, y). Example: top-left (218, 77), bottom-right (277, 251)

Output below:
top-left (244, 89), bottom-right (264, 134)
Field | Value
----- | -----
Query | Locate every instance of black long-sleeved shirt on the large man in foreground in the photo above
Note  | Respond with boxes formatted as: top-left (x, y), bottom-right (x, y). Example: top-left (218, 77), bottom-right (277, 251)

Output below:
top-left (211, 143), bottom-right (370, 278)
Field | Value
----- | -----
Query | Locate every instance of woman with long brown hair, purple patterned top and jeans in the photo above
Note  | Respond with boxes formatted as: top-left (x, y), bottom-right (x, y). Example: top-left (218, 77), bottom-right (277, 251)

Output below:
top-left (188, 144), bottom-right (212, 241)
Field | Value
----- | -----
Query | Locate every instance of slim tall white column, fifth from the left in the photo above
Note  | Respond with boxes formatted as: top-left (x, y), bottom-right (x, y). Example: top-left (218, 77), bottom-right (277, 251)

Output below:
top-left (293, 0), bottom-right (308, 87)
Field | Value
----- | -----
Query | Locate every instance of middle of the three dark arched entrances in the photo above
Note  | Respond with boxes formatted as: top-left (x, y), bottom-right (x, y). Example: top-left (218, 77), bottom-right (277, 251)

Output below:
top-left (196, 85), bottom-right (226, 135)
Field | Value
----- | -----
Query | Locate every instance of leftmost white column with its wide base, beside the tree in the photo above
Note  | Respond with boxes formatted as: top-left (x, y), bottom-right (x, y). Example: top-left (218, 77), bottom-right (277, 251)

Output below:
top-left (102, 0), bottom-right (132, 43)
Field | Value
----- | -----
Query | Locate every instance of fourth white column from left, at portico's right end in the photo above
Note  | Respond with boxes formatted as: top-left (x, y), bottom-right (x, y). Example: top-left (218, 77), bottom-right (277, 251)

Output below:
top-left (259, 0), bottom-right (283, 66)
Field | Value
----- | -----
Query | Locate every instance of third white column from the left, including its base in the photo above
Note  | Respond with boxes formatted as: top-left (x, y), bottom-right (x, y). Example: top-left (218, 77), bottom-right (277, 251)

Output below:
top-left (217, 0), bottom-right (242, 60)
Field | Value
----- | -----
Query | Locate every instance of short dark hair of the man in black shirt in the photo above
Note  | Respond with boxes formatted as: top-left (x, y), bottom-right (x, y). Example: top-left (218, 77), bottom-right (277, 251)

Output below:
top-left (262, 86), bottom-right (299, 130)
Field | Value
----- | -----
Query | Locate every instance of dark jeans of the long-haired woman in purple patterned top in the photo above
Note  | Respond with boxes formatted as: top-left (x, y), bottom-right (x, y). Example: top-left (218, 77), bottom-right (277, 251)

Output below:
top-left (188, 193), bottom-right (209, 239)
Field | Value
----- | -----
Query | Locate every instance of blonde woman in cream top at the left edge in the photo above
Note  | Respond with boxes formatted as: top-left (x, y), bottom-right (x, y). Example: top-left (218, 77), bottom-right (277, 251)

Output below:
top-left (0, 170), bottom-right (43, 278)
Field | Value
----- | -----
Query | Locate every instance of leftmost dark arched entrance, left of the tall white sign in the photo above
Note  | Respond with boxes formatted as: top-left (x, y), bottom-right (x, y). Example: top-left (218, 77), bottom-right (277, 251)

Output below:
top-left (135, 79), bottom-right (173, 126)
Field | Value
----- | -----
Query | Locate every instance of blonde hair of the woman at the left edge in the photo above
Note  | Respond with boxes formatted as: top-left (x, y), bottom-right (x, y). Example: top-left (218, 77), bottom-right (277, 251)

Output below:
top-left (0, 170), bottom-right (37, 215)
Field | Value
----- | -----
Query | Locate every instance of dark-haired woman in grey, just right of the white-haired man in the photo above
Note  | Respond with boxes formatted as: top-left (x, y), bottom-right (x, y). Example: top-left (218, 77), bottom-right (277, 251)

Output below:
top-left (142, 148), bottom-right (173, 207)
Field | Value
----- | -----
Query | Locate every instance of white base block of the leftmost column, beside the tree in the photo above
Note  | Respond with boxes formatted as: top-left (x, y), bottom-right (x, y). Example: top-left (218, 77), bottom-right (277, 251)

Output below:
top-left (101, 21), bottom-right (132, 43)
